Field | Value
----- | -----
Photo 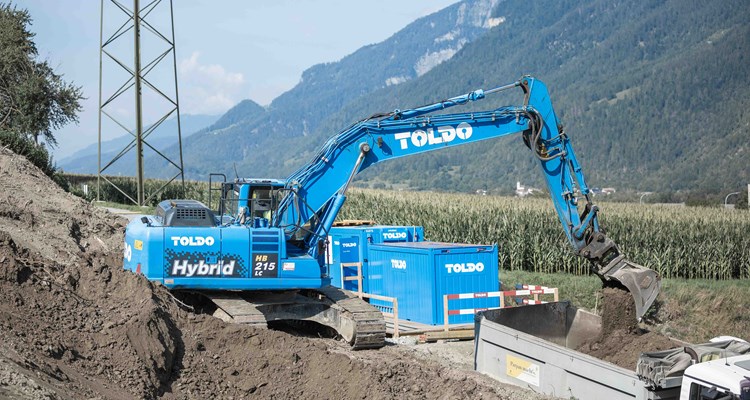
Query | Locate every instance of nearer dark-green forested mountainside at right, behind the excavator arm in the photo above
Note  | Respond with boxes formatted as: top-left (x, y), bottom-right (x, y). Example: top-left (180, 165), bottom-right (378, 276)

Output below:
top-left (318, 1), bottom-right (750, 192)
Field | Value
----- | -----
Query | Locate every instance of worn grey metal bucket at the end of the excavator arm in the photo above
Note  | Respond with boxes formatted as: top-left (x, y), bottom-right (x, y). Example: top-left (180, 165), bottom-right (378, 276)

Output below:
top-left (601, 259), bottom-right (661, 321)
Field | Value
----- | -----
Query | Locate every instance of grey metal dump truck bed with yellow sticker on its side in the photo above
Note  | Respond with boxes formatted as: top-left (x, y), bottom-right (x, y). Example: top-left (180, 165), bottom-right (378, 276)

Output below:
top-left (474, 302), bottom-right (681, 400)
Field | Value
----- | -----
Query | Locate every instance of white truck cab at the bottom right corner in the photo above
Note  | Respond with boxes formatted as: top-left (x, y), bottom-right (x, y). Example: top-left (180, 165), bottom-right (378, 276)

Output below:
top-left (680, 354), bottom-right (750, 400)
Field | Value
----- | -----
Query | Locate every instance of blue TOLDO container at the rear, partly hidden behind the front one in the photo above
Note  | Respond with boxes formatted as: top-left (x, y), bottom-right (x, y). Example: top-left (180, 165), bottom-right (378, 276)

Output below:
top-left (326, 225), bottom-right (424, 292)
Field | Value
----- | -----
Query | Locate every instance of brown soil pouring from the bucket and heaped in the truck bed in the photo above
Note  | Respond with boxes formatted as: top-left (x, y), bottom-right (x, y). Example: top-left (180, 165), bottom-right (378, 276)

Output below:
top-left (576, 288), bottom-right (678, 370)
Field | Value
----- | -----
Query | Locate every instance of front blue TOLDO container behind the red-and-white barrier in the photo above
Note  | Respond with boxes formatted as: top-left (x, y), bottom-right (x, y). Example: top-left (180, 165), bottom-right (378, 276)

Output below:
top-left (367, 242), bottom-right (500, 325)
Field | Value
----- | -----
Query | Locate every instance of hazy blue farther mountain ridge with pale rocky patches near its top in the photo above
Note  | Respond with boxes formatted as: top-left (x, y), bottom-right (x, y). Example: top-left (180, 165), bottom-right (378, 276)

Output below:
top-left (147, 0), bottom-right (506, 179)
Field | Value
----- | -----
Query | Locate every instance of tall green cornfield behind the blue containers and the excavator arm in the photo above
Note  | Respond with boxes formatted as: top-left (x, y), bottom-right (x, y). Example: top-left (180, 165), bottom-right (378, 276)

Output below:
top-left (339, 189), bottom-right (750, 279)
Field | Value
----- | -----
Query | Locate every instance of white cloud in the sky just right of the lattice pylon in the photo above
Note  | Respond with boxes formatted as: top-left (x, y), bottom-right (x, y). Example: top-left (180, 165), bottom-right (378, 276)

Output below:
top-left (177, 51), bottom-right (245, 114)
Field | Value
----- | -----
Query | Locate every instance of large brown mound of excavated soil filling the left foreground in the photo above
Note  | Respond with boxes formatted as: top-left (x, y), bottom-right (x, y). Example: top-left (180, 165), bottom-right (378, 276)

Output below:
top-left (0, 147), bottom-right (547, 399)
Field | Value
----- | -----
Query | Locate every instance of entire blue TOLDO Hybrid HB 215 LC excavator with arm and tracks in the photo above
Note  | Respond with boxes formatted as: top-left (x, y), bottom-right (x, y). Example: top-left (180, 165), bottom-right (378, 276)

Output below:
top-left (124, 76), bottom-right (660, 349)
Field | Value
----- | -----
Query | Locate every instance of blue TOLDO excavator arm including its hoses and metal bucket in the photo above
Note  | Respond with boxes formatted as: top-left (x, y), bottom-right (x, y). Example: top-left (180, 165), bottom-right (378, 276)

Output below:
top-left (271, 76), bottom-right (660, 318)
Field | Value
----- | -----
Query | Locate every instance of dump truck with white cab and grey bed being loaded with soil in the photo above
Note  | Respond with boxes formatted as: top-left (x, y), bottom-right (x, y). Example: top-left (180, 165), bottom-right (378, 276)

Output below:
top-left (474, 302), bottom-right (750, 400)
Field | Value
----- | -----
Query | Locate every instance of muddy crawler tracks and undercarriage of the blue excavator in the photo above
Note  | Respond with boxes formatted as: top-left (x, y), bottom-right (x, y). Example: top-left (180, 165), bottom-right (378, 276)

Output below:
top-left (203, 286), bottom-right (385, 350)
